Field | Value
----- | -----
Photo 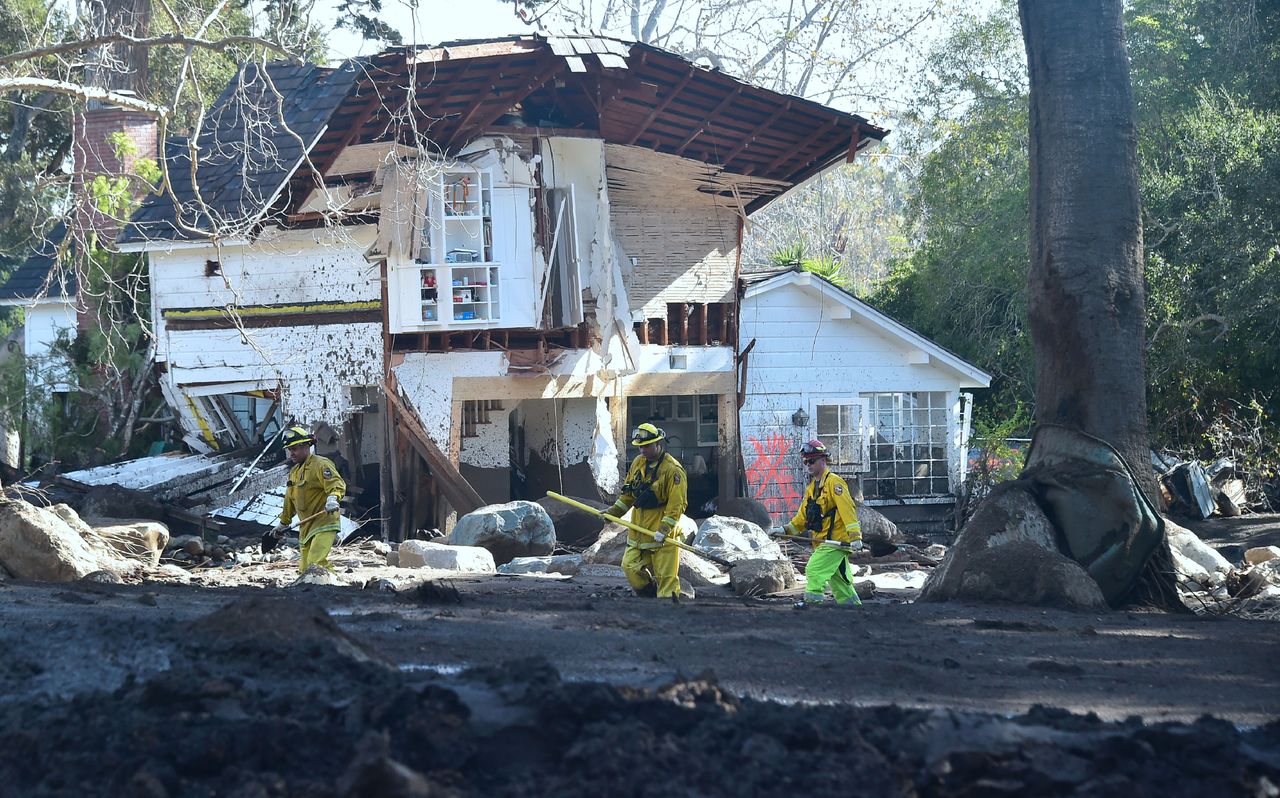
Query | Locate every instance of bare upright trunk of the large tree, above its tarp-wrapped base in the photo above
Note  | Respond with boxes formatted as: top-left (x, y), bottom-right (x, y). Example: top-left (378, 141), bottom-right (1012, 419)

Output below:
top-left (1019, 0), bottom-right (1156, 501)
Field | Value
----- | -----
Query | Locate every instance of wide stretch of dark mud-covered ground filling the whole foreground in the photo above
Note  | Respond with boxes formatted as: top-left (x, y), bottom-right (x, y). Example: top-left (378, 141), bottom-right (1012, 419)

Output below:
top-left (0, 532), bottom-right (1280, 798)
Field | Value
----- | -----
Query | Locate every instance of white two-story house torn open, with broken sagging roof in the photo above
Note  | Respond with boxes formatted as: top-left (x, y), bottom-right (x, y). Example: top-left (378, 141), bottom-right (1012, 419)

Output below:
top-left (119, 36), bottom-right (886, 538)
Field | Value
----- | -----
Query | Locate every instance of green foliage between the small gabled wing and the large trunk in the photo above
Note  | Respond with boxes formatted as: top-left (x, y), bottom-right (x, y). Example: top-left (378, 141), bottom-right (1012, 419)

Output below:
top-left (868, 7), bottom-right (1034, 407)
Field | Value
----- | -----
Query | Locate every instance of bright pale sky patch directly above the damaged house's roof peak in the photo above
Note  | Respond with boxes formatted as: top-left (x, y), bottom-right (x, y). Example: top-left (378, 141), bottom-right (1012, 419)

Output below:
top-left (317, 0), bottom-right (534, 60)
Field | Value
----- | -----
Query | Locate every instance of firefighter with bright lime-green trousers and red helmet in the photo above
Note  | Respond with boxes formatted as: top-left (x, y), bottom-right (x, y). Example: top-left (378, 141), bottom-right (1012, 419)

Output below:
top-left (782, 439), bottom-right (863, 608)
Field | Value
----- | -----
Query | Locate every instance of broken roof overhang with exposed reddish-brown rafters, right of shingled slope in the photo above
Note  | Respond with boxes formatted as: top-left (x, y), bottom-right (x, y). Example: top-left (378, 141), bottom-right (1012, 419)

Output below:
top-left (289, 36), bottom-right (888, 213)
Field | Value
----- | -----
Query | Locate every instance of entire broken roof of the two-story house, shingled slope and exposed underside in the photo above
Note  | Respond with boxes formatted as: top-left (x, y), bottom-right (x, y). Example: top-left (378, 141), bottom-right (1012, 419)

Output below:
top-left (119, 36), bottom-right (888, 243)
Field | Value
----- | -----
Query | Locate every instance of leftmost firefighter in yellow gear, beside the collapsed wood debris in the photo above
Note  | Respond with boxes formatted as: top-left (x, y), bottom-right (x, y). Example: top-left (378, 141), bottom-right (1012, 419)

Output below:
top-left (276, 427), bottom-right (347, 573)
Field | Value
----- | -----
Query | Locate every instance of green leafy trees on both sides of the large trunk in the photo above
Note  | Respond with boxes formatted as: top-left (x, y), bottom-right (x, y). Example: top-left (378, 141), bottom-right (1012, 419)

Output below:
top-left (869, 0), bottom-right (1280, 456)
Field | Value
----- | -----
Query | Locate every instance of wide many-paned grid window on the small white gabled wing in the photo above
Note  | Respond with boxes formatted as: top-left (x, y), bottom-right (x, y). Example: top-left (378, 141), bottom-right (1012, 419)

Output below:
top-left (863, 391), bottom-right (951, 498)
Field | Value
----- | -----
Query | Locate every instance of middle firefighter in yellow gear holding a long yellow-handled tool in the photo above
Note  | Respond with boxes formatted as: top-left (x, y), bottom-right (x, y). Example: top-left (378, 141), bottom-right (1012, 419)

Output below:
top-left (607, 424), bottom-right (689, 602)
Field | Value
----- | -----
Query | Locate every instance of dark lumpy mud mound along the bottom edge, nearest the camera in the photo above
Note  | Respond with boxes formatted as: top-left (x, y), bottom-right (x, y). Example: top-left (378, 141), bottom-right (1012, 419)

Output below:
top-left (0, 637), bottom-right (1280, 798)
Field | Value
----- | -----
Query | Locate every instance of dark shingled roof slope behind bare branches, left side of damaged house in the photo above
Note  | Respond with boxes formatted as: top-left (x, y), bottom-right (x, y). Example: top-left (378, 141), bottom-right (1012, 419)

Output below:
top-left (116, 61), bottom-right (356, 243)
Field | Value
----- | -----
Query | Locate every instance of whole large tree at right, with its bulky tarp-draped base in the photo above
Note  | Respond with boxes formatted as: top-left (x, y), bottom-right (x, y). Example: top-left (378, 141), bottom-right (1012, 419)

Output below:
top-left (922, 0), bottom-right (1178, 607)
